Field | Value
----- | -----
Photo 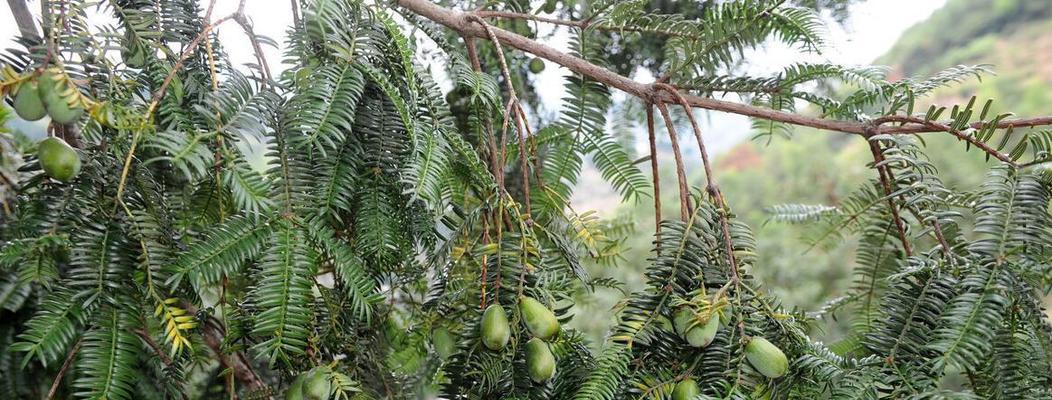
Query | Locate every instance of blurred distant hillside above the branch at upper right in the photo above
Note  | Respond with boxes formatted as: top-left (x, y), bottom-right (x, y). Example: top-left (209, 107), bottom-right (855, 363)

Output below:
top-left (876, 0), bottom-right (1052, 115)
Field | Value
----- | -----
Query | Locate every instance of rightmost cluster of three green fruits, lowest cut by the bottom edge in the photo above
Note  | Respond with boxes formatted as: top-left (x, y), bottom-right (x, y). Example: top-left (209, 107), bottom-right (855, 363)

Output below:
top-left (672, 303), bottom-right (789, 400)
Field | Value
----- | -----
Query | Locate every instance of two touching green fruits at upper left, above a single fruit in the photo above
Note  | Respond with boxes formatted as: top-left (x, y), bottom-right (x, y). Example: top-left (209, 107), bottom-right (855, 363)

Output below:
top-left (14, 68), bottom-right (84, 124)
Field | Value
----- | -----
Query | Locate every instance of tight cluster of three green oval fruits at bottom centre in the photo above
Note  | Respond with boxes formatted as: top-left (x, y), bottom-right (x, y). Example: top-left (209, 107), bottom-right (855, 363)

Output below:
top-left (482, 296), bottom-right (559, 383)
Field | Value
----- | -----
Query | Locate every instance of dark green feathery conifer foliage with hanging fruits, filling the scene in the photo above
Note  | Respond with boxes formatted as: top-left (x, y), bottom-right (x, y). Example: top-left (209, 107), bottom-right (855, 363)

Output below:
top-left (0, 0), bottom-right (1052, 400)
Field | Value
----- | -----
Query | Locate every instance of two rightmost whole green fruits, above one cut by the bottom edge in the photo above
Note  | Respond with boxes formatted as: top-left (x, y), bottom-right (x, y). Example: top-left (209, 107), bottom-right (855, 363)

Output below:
top-left (672, 307), bottom-right (789, 378)
